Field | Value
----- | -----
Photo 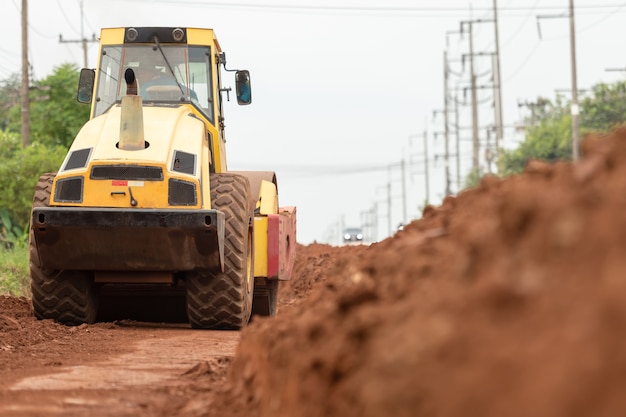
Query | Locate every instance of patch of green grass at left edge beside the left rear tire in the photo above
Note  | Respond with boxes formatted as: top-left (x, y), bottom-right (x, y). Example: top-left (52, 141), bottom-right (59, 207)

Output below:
top-left (0, 243), bottom-right (30, 297)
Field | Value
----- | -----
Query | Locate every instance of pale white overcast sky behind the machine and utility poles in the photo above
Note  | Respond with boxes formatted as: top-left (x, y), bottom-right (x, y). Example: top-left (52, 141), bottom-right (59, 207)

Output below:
top-left (0, 0), bottom-right (626, 244)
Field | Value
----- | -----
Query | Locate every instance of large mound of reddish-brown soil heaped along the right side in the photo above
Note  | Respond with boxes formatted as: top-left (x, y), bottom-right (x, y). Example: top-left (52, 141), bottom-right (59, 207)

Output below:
top-left (213, 130), bottom-right (626, 417)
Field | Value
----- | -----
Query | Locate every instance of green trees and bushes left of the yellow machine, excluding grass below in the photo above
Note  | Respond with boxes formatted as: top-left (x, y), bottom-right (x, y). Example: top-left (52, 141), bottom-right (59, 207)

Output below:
top-left (0, 64), bottom-right (89, 237)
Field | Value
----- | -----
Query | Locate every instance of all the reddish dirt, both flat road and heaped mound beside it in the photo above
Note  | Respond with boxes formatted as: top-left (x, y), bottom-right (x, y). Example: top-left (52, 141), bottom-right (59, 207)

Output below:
top-left (0, 130), bottom-right (626, 417)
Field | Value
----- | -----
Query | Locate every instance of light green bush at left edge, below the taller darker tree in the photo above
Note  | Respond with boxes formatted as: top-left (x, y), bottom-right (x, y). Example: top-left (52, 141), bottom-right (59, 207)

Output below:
top-left (0, 132), bottom-right (67, 229)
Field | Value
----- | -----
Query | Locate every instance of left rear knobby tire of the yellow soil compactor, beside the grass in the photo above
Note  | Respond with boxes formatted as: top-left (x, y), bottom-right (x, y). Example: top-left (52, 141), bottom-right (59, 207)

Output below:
top-left (29, 173), bottom-right (98, 326)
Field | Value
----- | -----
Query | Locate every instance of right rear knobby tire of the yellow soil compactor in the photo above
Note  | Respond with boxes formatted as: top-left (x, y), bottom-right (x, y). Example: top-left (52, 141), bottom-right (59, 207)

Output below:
top-left (185, 173), bottom-right (254, 329)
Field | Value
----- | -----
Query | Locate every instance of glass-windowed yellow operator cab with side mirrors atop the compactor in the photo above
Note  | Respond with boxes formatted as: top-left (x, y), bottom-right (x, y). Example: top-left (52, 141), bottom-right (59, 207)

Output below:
top-left (77, 28), bottom-right (251, 130)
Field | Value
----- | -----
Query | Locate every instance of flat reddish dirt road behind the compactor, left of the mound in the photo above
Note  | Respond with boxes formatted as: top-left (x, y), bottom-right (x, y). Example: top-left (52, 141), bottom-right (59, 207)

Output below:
top-left (0, 297), bottom-right (240, 416)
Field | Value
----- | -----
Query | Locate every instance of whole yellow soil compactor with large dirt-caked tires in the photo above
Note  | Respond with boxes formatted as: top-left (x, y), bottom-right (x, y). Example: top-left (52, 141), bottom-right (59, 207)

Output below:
top-left (30, 27), bottom-right (296, 329)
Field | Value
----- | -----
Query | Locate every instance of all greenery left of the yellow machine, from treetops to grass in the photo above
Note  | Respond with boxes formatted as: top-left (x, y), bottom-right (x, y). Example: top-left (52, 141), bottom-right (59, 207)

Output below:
top-left (0, 64), bottom-right (89, 297)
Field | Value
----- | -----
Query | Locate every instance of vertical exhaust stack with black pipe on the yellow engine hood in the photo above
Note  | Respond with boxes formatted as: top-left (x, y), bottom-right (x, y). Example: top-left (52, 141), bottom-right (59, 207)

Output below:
top-left (119, 68), bottom-right (146, 151)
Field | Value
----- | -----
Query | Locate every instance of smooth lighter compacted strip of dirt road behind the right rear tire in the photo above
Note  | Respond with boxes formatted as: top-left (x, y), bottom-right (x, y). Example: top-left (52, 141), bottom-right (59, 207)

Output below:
top-left (0, 328), bottom-right (240, 416)
